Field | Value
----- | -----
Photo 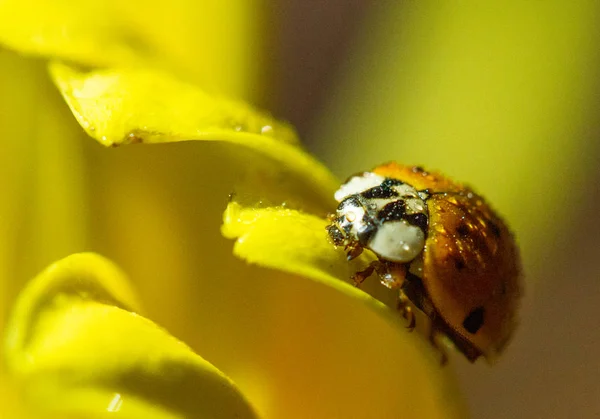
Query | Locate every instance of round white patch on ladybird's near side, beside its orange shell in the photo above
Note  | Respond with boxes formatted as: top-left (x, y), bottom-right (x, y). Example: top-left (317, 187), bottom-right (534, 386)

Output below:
top-left (368, 221), bottom-right (425, 263)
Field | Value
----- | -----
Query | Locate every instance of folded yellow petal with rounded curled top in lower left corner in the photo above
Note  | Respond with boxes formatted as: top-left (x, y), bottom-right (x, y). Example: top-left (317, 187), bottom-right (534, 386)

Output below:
top-left (6, 254), bottom-right (255, 419)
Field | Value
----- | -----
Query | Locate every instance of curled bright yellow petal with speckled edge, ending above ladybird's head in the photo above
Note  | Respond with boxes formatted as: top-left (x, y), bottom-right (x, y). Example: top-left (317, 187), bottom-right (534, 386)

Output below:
top-left (51, 64), bottom-right (338, 214)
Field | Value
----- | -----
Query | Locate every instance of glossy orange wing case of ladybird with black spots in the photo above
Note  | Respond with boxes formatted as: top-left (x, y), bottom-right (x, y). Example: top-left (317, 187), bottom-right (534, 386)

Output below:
top-left (372, 163), bottom-right (522, 360)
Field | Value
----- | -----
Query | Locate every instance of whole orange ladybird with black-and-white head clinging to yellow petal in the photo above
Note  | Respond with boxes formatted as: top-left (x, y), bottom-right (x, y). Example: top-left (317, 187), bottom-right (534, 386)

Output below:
top-left (327, 163), bottom-right (521, 362)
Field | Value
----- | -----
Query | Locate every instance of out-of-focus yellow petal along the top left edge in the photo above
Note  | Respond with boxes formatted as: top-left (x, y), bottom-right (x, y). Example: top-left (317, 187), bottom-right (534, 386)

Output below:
top-left (0, 0), bottom-right (269, 98)
